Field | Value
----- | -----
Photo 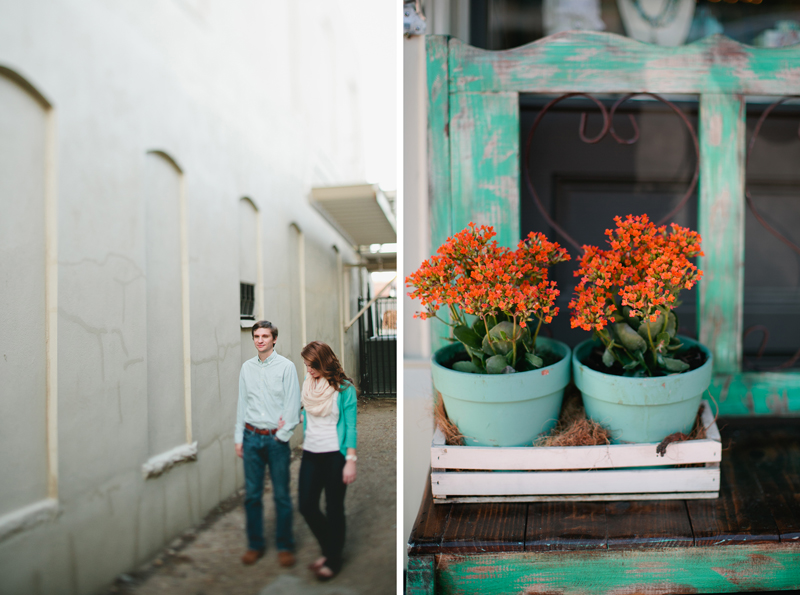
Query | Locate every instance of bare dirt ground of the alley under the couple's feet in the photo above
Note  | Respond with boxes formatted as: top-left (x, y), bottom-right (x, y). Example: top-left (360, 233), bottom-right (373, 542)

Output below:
top-left (106, 399), bottom-right (397, 595)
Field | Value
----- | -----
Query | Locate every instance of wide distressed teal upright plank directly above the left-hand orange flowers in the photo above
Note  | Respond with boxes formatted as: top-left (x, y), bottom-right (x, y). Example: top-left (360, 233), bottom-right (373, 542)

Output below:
top-left (450, 93), bottom-right (520, 247)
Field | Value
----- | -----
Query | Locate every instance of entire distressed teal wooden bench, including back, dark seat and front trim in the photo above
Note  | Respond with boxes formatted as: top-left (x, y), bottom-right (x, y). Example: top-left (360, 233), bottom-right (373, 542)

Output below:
top-left (407, 32), bottom-right (800, 595)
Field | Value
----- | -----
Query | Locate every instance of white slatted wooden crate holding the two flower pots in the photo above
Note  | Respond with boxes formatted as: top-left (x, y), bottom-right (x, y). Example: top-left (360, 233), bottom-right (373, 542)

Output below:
top-left (431, 401), bottom-right (722, 503)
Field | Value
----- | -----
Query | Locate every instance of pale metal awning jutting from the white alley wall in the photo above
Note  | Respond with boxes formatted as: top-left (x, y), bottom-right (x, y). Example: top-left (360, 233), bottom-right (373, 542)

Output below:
top-left (311, 184), bottom-right (397, 246)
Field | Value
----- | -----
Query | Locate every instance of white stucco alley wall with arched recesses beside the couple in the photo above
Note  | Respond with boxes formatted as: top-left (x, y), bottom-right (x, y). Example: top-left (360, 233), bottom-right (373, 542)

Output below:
top-left (0, 0), bottom-right (363, 594)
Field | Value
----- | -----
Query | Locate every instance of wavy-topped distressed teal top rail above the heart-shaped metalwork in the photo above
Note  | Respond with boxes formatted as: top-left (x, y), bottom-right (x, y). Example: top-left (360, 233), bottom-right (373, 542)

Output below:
top-left (450, 31), bottom-right (800, 95)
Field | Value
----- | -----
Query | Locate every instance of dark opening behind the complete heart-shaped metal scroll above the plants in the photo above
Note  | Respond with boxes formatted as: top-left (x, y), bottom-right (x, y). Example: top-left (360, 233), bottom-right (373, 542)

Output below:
top-left (520, 95), bottom-right (697, 346)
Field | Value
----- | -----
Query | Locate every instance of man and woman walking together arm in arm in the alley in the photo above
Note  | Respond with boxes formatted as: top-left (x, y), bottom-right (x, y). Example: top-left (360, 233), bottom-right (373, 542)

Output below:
top-left (234, 320), bottom-right (357, 580)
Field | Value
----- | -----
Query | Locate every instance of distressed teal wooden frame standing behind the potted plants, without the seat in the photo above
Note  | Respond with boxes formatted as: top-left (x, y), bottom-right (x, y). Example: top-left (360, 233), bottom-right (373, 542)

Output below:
top-left (427, 32), bottom-right (800, 415)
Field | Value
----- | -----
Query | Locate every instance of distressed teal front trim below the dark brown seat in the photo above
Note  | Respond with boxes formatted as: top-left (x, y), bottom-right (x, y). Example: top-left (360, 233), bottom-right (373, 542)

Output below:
top-left (434, 544), bottom-right (800, 595)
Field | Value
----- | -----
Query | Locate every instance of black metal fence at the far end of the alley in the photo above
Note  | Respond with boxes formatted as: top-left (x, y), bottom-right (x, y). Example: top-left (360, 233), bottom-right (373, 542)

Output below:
top-left (358, 298), bottom-right (397, 397)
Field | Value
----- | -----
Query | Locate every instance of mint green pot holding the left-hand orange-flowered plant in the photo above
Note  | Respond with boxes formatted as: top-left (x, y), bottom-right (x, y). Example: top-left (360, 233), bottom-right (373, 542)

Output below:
top-left (431, 337), bottom-right (570, 446)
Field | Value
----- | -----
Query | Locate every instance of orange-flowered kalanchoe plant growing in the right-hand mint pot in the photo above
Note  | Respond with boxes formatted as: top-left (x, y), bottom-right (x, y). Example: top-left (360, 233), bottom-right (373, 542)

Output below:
top-left (569, 215), bottom-right (703, 376)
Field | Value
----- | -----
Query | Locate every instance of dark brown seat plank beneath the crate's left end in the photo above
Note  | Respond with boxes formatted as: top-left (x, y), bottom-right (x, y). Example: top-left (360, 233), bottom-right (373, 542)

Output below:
top-left (441, 503), bottom-right (528, 554)
